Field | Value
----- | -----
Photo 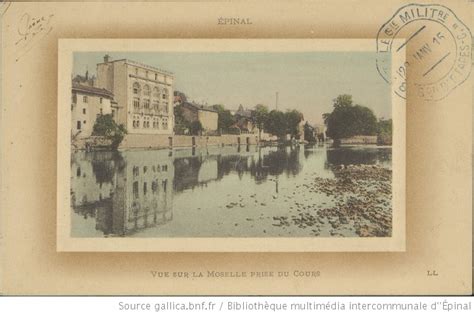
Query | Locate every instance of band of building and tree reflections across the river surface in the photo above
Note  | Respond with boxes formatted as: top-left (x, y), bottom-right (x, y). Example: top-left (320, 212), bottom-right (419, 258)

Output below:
top-left (71, 146), bottom-right (391, 237)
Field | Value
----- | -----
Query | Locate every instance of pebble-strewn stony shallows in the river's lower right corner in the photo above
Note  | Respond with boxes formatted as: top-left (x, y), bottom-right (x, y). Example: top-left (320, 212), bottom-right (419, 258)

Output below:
top-left (273, 165), bottom-right (392, 237)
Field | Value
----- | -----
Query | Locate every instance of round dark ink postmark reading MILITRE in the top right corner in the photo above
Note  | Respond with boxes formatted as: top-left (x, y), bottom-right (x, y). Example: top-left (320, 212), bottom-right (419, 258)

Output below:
top-left (377, 4), bottom-right (472, 100)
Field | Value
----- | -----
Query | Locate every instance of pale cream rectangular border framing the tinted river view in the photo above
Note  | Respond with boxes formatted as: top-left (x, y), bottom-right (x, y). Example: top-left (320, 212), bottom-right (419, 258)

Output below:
top-left (57, 39), bottom-right (406, 252)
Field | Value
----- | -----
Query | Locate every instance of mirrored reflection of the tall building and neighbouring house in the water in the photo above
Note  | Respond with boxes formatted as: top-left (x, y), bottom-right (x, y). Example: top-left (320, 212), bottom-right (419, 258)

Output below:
top-left (71, 150), bottom-right (174, 237)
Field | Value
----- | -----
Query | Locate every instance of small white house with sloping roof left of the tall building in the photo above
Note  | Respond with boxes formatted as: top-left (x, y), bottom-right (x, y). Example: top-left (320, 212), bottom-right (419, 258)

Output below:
top-left (71, 82), bottom-right (116, 139)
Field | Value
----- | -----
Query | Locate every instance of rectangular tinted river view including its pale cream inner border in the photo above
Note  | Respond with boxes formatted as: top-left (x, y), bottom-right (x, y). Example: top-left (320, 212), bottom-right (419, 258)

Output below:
top-left (58, 39), bottom-right (405, 251)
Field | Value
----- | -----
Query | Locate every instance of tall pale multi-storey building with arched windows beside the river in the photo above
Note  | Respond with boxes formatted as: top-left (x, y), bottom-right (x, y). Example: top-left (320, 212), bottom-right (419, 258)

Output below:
top-left (97, 55), bottom-right (174, 135)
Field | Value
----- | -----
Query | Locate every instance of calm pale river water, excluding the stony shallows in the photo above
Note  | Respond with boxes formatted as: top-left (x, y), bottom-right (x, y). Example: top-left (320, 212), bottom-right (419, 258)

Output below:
top-left (71, 145), bottom-right (392, 237)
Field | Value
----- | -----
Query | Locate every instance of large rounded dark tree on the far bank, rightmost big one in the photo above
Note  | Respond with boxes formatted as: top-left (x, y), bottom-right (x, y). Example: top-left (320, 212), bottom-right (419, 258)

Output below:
top-left (323, 94), bottom-right (377, 145)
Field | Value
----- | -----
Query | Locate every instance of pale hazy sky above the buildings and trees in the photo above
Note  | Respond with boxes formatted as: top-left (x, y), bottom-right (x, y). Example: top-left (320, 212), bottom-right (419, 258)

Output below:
top-left (73, 51), bottom-right (391, 123)
